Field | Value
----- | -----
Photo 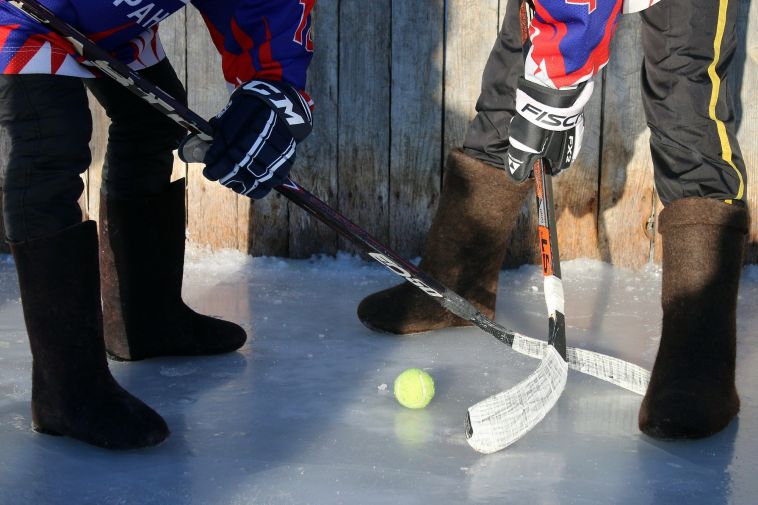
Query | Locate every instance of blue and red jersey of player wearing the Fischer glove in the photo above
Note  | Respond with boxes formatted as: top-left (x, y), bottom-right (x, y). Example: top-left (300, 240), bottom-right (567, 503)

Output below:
top-left (525, 0), bottom-right (659, 88)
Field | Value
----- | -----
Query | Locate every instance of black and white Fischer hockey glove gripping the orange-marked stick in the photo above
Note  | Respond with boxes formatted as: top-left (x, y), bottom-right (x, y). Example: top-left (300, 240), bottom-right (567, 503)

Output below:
top-left (508, 77), bottom-right (593, 182)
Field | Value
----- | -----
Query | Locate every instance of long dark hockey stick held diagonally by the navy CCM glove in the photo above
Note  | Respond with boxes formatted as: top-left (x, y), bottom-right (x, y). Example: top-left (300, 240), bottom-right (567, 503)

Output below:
top-left (6, 0), bottom-right (650, 395)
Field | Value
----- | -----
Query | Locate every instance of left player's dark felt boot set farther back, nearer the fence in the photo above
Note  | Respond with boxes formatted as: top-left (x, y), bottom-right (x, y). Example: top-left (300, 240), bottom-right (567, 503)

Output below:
top-left (100, 180), bottom-right (246, 360)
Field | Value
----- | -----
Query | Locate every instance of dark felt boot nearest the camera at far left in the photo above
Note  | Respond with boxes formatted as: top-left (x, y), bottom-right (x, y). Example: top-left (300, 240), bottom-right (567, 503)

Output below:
top-left (11, 221), bottom-right (169, 449)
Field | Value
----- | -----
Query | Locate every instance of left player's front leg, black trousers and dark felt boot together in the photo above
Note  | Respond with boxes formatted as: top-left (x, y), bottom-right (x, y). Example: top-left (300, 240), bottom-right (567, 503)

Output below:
top-left (0, 75), bottom-right (168, 449)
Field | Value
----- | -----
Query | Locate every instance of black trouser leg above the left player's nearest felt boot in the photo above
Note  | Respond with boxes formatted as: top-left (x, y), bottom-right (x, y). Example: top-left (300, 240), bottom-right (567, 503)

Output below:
top-left (0, 75), bottom-right (92, 242)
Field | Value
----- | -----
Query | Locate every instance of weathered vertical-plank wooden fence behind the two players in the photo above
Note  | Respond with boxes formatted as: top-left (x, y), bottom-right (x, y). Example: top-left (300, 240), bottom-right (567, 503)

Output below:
top-left (0, 0), bottom-right (758, 268)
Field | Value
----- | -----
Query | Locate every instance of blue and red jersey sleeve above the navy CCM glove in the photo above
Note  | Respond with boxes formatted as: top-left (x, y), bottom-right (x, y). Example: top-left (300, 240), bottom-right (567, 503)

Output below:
top-left (192, 0), bottom-right (315, 91)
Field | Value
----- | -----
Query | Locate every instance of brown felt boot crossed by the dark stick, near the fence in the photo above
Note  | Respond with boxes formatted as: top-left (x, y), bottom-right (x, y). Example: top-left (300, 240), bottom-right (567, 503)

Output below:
top-left (358, 149), bottom-right (532, 334)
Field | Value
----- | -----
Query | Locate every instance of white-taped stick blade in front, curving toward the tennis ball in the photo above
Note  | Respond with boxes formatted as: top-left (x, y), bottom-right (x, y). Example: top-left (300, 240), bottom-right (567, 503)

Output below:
top-left (466, 346), bottom-right (568, 454)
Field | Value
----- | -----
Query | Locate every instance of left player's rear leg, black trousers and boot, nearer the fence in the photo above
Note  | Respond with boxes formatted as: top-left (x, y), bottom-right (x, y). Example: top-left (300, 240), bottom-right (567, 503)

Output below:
top-left (89, 60), bottom-right (246, 360)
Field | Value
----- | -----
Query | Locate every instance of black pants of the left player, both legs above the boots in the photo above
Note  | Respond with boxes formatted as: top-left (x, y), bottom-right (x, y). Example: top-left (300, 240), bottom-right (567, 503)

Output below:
top-left (0, 60), bottom-right (186, 242)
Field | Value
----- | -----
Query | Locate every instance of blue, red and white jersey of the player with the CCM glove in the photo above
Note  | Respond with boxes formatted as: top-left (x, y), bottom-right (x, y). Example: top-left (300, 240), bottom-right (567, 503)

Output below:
top-left (0, 0), bottom-right (315, 90)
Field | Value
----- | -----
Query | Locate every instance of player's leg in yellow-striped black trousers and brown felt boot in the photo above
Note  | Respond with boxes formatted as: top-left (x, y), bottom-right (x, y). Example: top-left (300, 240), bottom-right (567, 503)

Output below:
top-left (639, 0), bottom-right (748, 439)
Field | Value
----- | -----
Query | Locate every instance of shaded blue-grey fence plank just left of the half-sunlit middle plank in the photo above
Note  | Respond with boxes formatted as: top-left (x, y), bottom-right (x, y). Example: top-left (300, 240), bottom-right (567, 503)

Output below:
top-left (389, 0), bottom-right (445, 257)
